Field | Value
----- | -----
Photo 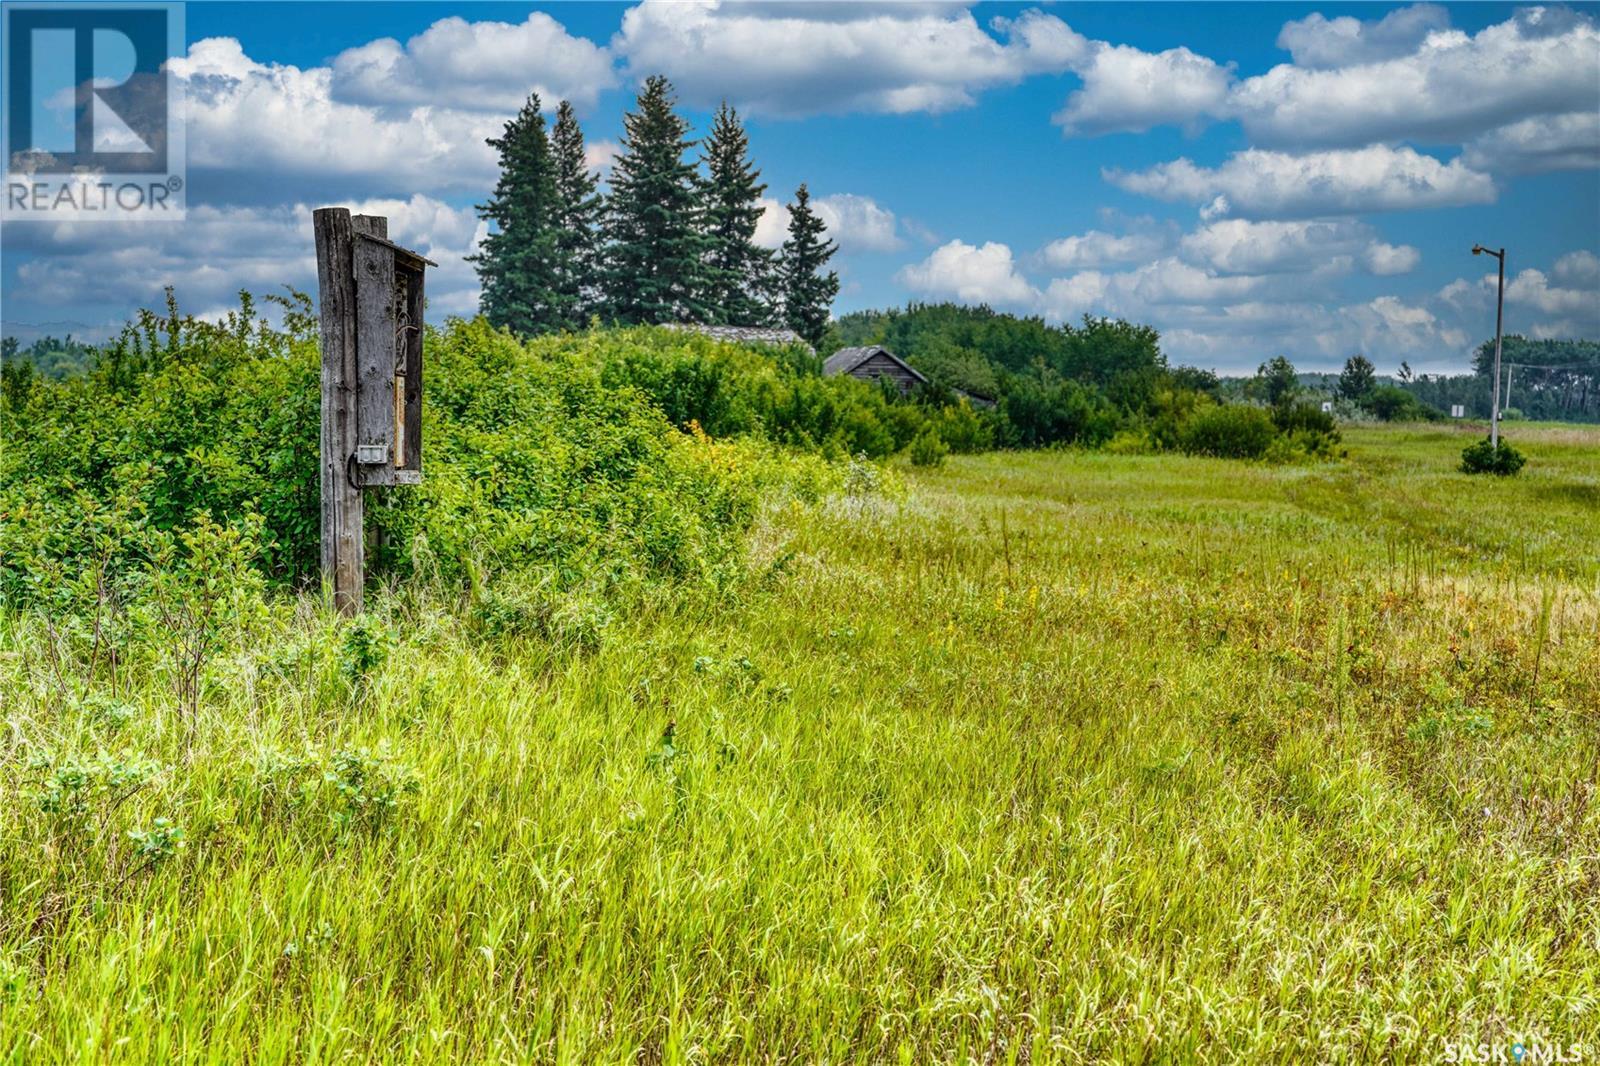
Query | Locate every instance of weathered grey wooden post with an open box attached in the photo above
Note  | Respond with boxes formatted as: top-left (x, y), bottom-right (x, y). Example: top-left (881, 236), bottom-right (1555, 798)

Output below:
top-left (312, 208), bottom-right (437, 615)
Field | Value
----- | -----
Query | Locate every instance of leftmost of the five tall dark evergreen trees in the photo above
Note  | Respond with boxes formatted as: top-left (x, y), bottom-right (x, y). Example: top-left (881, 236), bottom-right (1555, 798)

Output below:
top-left (469, 93), bottom-right (563, 335)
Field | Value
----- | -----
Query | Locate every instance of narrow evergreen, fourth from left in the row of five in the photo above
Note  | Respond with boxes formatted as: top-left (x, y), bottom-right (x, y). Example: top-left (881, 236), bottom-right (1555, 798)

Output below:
top-left (702, 101), bottom-right (773, 325)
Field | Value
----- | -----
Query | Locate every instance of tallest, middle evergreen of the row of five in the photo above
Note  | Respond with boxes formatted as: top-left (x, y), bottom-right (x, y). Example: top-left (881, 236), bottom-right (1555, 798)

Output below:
top-left (603, 74), bottom-right (709, 325)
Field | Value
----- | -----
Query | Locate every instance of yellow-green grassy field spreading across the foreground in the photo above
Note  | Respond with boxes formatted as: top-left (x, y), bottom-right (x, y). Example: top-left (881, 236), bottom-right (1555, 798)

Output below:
top-left (0, 426), bottom-right (1600, 1063)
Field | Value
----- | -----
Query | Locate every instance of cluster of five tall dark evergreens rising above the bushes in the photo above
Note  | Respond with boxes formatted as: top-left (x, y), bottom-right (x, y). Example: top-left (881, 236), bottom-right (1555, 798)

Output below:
top-left (470, 75), bottom-right (838, 346)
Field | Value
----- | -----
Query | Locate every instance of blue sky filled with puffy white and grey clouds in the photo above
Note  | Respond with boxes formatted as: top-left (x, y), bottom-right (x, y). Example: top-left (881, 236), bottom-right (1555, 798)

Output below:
top-left (0, 0), bottom-right (1600, 373)
